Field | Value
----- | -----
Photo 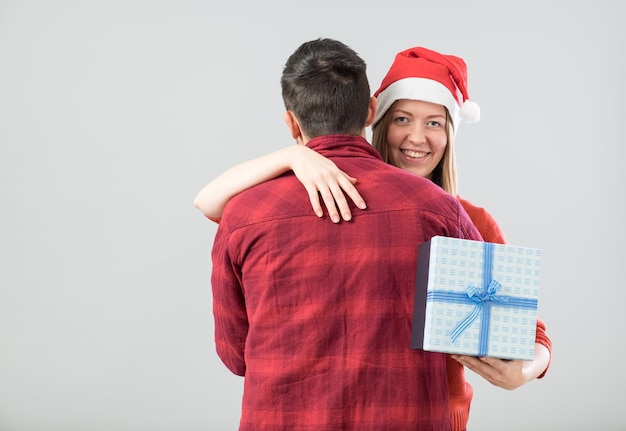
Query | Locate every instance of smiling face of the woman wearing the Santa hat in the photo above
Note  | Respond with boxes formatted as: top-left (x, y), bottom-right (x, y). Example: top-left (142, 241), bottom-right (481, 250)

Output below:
top-left (387, 99), bottom-right (448, 179)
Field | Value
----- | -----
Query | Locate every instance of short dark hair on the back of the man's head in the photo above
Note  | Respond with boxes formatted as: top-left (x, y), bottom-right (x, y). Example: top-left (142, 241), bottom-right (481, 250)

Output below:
top-left (280, 38), bottom-right (370, 138)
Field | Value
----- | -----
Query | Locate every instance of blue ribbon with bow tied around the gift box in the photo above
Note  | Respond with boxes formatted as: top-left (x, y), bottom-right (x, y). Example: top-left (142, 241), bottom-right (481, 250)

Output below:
top-left (426, 242), bottom-right (537, 356)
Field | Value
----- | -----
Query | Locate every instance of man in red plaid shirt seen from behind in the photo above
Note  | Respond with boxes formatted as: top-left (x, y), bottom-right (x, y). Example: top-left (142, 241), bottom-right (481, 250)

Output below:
top-left (211, 39), bottom-right (481, 431)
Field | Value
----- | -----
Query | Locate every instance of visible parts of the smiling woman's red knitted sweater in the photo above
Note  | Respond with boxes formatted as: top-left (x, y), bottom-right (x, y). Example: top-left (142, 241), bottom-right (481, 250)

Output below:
top-left (446, 196), bottom-right (552, 431)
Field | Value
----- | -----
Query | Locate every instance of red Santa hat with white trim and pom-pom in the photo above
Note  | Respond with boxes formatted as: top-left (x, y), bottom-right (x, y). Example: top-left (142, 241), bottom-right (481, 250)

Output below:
top-left (373, 47), bottom-right (480, 130)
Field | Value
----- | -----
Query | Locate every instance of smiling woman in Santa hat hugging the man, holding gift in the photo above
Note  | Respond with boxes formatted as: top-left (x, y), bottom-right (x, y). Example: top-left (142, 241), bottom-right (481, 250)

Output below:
top-left (194, 47), bottom-right (552, 430)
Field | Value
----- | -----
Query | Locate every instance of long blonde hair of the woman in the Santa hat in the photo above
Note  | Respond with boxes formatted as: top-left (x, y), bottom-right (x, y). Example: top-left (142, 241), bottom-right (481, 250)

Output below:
top-left (372, 101), bottom-right (457, 197)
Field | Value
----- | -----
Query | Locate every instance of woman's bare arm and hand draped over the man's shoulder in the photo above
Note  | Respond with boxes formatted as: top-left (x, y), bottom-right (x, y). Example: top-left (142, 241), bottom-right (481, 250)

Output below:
top-left (193, 145), bottom-right (366, 223)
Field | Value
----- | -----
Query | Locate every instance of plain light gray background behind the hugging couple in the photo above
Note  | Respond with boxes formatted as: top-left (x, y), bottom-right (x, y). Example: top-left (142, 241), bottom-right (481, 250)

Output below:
top-left (0, 0), bottom-right (626, 431)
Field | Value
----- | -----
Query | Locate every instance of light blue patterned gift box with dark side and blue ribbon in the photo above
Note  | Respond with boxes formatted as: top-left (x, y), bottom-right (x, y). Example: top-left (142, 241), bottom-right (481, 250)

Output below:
top-left (411, 236), bottom-right (541, 360)
